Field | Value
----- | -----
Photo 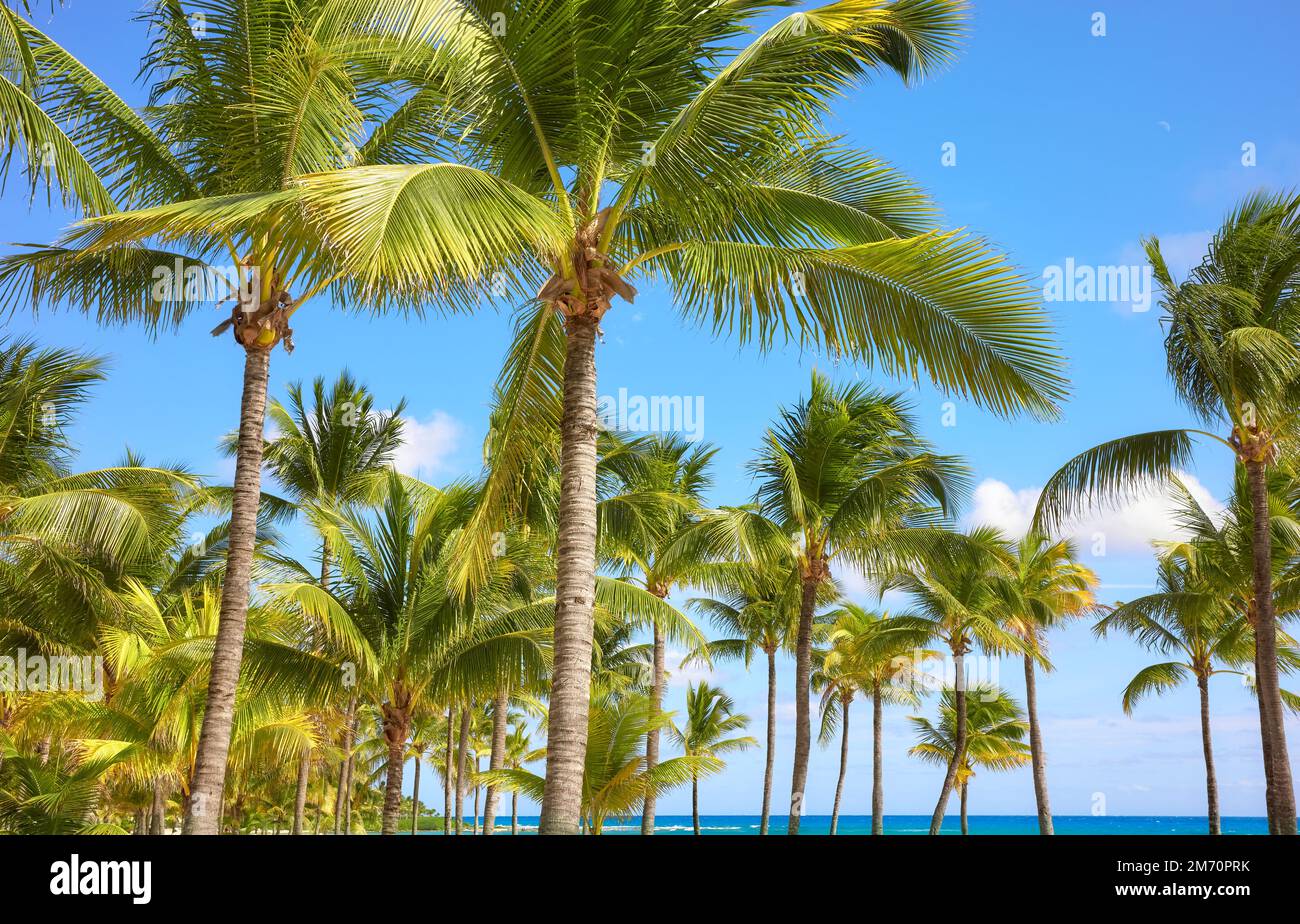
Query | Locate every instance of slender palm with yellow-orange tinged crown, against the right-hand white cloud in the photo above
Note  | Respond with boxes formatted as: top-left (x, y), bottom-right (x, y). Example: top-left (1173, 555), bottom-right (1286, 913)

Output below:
top-left (1008, 533), bottom-right (1097, 834)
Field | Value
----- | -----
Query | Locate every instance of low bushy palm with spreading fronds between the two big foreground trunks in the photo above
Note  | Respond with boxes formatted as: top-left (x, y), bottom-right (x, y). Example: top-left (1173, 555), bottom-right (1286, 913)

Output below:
top-left (265, 472), bottom-right (554, 834)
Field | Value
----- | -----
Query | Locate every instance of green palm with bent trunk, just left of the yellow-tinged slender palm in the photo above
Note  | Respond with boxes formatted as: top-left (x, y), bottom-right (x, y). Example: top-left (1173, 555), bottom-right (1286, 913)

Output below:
top-left (892, 526), bottom-right (1024, 834)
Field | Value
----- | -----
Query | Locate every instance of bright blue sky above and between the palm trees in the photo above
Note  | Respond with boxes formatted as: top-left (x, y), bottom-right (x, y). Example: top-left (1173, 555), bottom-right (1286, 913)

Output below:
top-left (0, 0), bottom-right (1300, 815)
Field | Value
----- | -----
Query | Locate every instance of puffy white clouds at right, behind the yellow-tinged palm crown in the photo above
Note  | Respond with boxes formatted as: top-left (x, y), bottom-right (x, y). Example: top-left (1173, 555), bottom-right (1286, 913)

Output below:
top-left (969, 473), bottom-right (1223, 552)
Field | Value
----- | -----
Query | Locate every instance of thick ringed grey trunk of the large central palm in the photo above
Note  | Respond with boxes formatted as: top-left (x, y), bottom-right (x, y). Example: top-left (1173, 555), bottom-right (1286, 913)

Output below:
top-left (538, 314), bottom-right (597, 834)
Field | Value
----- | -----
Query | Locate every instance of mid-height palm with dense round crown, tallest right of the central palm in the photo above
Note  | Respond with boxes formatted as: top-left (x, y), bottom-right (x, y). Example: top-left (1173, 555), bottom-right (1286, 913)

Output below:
top-left (750, 372), bottom-right (966, 834)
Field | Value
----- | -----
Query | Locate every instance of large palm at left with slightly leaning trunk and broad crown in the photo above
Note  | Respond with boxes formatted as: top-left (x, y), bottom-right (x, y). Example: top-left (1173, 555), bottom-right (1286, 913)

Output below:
top-left (0, 0), bottom-right (554, 833)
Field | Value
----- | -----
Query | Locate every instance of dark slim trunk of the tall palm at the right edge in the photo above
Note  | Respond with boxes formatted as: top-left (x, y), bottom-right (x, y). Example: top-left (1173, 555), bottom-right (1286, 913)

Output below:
top-left (1245, 460), bottom-right (1296, 836)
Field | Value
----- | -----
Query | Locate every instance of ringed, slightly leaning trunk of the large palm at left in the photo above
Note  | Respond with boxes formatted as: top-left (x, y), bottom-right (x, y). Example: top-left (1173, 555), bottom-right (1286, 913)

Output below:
top-left (185, 348), bottom-right (270, 834)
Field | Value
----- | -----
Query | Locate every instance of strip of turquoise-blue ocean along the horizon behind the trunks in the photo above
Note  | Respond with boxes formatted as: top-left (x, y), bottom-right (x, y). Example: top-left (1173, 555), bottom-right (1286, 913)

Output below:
top-left (431, 815), bottom-right (1269, 834)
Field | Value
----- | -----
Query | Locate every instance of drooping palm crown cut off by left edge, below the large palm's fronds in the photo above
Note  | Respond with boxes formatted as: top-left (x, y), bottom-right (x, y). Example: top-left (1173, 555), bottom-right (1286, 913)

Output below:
top-left (0, 338), bottom-right (198, 665)
